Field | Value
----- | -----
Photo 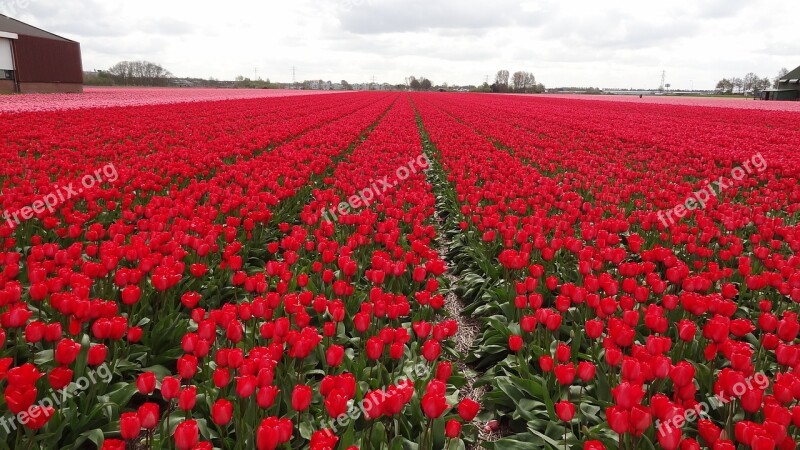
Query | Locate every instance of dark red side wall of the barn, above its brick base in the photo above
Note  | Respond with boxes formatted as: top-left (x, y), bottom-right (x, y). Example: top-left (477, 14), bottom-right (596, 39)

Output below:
top-left (14, 35), bottom-right (83, 83)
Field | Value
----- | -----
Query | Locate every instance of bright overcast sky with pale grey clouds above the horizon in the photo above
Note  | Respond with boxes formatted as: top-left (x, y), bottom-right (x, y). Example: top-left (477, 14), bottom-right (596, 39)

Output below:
top-left (0, 0), bottom-right (800, 89)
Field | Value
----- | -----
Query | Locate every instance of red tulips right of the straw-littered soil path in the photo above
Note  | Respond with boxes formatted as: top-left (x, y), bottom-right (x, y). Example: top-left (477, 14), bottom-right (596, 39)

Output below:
top-left (415, 95), bottom-right (800, 449)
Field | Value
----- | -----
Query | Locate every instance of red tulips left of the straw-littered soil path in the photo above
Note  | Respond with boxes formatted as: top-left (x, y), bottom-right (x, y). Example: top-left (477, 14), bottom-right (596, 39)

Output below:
top-left (0, 94), bottom-right (488, 449)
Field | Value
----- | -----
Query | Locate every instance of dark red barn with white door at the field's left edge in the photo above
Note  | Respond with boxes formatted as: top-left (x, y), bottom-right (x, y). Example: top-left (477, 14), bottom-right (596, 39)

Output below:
top-left (0, 15), bottom-right (83, 93)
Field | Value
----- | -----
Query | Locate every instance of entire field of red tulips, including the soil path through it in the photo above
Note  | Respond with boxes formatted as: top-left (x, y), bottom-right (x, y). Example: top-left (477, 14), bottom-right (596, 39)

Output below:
top-left (0, 90), bottom-right (800, 450)
